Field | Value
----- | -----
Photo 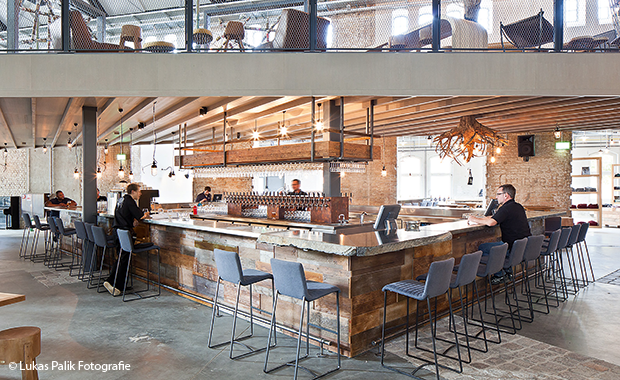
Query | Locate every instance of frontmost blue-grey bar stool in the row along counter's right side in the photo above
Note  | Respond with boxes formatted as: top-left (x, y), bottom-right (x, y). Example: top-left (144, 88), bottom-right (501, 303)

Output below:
top-left (381, 258), bottom-right (463, 380)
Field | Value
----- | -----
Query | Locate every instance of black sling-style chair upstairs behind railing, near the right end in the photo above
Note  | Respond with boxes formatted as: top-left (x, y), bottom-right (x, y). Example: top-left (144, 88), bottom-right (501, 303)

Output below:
top-left (499, 9), bottom-right (553, 51)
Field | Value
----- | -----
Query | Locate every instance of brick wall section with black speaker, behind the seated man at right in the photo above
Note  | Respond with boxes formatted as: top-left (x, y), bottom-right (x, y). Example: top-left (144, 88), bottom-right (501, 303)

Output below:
top-left (486, 132), bottom-right (572, 211)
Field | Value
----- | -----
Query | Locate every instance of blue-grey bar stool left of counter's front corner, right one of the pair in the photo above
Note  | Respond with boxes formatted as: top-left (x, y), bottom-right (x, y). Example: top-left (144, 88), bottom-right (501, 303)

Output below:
top-left (263, 259), bottom-right (341, 379)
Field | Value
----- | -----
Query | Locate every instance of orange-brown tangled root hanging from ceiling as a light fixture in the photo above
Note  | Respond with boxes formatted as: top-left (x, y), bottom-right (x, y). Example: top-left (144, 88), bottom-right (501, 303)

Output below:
top-left (433, 116), bottom-right (508, 165)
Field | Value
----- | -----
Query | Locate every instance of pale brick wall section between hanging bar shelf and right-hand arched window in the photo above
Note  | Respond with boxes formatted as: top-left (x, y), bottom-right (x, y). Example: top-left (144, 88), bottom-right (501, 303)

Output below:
top-left (340, 137), bottom-right (396, 206)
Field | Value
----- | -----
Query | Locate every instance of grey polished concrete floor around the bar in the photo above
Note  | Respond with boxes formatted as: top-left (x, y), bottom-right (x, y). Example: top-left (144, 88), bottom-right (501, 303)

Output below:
top-left (0, 229), bottom-right (620, 380)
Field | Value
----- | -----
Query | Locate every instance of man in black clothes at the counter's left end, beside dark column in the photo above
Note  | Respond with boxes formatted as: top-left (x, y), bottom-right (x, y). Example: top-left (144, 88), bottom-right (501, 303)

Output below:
top-left (103, 183), bottom-right (151, 296)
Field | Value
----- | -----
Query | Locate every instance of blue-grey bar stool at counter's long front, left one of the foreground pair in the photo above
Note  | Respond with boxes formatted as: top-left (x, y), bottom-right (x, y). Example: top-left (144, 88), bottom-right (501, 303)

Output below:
top-left (207, 248), bottom-right (274, 359)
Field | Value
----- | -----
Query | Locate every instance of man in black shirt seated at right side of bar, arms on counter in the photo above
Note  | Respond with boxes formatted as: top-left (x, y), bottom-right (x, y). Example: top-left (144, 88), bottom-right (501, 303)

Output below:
top-left (468, 184), bottom-right (532, 284)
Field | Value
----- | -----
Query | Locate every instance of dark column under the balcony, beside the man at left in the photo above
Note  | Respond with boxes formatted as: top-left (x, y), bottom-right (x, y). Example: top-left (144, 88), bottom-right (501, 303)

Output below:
top-left (82, 106), bottom-right (97, 223)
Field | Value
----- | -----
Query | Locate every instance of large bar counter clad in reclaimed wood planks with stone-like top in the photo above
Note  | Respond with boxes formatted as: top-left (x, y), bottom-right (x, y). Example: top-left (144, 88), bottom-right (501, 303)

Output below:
top-left (44, 206), bottom-right (563, 356)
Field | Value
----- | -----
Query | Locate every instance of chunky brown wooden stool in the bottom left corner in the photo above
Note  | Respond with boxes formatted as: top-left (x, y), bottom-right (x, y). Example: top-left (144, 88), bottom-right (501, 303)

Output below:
top-left (0, 326), bottom-right (41, 380)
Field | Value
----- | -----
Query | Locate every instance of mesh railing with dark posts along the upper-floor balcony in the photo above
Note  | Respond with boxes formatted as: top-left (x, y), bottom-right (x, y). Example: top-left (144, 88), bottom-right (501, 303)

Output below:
top-left (0, 0), bottom-right (620, 53)
